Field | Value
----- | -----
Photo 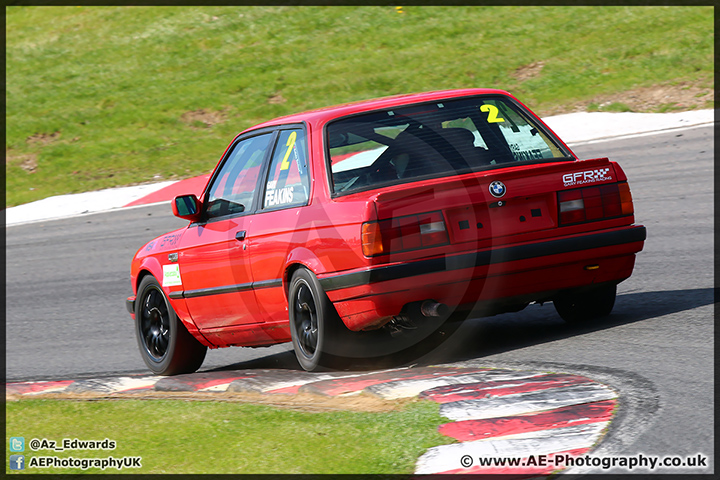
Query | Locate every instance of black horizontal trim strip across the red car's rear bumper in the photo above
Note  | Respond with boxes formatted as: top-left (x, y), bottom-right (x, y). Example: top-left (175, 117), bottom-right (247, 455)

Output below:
top-left (320, 226), bottom-right (647, 292)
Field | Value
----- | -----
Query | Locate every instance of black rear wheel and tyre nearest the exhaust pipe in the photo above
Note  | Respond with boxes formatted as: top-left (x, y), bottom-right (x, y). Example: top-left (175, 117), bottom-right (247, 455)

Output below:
top-left (288, 268), bottom-right (345, 372)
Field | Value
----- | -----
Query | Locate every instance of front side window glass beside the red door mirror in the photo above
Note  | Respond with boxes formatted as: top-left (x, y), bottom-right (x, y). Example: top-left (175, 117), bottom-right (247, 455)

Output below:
top-left (206, 133), bottom-right (272, 219)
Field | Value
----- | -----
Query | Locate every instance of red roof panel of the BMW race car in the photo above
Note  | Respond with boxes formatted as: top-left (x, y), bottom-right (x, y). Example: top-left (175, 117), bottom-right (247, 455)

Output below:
top-left (242, 88), bottom-right (512, 133)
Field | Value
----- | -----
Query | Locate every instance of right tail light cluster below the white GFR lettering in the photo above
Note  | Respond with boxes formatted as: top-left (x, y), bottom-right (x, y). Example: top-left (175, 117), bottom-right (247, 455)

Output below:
top-left (558, 182), bottom-right (633, 225)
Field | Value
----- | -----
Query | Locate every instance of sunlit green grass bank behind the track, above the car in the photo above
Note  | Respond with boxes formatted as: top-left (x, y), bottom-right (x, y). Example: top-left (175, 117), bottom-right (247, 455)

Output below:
top-left (6, 6), bottom-right (714, 206)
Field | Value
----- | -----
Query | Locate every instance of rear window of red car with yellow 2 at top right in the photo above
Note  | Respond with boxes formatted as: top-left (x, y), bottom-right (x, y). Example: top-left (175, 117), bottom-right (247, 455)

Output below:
top-left (326, 95), bottom-right (572, 194)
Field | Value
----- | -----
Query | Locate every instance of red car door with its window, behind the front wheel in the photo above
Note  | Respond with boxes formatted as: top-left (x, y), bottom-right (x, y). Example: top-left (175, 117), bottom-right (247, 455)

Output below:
top-left (178, 132), bottom-right (275, 330)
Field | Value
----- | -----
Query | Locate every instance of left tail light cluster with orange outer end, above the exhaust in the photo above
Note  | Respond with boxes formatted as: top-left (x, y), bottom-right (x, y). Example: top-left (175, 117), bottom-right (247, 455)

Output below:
top-left (362, 212), bottom-right (449, 257)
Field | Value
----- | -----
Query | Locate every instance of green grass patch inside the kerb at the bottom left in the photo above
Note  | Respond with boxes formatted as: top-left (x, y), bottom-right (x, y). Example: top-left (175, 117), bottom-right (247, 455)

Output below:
top-left (6, 400), bottom-right (452, 474)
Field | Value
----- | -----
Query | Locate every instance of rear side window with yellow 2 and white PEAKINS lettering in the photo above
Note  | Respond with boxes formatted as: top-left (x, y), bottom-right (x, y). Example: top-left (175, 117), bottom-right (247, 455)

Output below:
top-left (263, 128), bottom-right (310, 209)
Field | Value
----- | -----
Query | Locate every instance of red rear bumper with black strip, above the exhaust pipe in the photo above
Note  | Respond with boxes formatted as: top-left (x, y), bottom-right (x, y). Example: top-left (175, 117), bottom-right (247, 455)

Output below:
top-left (319, 226), bottom-right (647, 330)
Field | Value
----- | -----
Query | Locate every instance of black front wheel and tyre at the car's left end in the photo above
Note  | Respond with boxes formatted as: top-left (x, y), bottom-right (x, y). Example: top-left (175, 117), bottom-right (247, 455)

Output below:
top-left (135, 275), bottom-right (207, 375)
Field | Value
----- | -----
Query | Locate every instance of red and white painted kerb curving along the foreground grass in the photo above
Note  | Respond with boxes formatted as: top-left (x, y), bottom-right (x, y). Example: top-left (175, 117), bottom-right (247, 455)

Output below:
top-left (6, 366), bottom-right (618, 479)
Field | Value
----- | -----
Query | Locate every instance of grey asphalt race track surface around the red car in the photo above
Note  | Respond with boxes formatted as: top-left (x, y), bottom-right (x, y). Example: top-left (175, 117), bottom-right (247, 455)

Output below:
top-left (6, 127), bottom-right (714, 473)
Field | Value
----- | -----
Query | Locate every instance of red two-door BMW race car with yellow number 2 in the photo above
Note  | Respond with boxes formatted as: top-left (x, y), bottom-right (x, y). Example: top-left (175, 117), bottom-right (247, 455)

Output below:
top-left (127, 89), bottom-right (646, 375)
